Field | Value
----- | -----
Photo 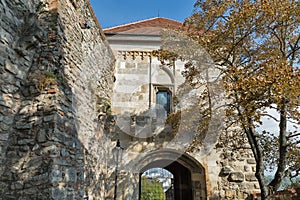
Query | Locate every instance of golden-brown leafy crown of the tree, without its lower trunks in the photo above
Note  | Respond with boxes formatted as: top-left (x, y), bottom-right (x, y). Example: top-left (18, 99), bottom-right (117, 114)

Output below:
top-left (184, 0), bottom-right (300, 125)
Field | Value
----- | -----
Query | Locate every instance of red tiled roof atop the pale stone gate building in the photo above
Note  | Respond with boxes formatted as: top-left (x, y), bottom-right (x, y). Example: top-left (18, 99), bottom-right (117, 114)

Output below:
top-left (104, 17), bottom-right (182, 35)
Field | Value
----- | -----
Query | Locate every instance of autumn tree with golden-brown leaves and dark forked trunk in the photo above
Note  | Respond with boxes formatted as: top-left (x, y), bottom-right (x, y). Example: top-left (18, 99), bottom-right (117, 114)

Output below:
top-left (180, 0), bottom-right (300, 199)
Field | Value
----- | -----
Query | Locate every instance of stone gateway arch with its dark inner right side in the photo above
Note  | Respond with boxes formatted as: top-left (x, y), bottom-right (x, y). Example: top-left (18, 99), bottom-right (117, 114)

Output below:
top-left (136, 150), bottom-right (207, 200)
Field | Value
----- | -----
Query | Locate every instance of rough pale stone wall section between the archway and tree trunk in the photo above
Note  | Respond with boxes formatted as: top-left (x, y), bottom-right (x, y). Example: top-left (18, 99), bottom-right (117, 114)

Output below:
top-left (202, 135), bottom-right (260, 199)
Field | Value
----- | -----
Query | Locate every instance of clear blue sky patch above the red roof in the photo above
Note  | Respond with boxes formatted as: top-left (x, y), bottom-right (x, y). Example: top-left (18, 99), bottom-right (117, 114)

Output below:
top-left (90, 0), bottom-right (196, 28)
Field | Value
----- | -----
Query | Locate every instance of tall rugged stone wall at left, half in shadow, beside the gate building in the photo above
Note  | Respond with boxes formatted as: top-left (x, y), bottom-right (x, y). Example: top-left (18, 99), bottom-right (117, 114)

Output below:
top-left (0, 0), bottom-right (114, 199)
